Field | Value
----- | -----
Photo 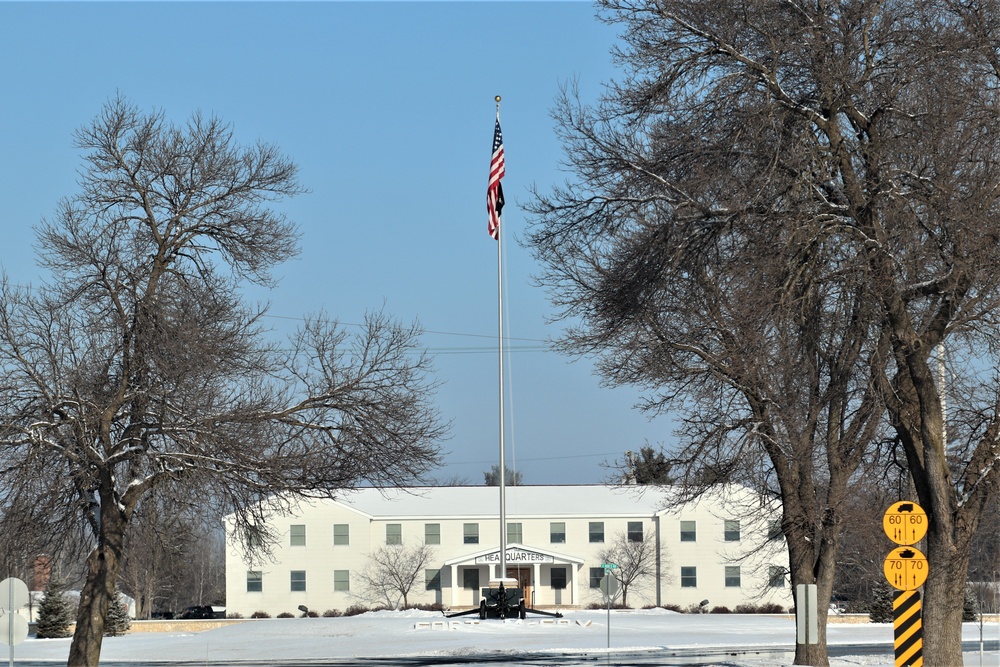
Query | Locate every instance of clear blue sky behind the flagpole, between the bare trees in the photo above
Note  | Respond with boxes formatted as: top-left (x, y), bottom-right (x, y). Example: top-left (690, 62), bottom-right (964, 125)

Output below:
top-left (0, 2), bottom-right (671, 484)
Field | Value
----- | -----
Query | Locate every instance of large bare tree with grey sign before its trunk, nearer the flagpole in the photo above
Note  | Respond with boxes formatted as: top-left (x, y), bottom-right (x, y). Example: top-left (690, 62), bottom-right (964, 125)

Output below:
top-left (529, 2), bottom-right (888, 665)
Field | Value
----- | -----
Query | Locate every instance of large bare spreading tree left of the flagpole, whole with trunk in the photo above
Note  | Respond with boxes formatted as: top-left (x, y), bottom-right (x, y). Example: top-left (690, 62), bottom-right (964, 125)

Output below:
top-left (0, 98), bottom-right (444, 666)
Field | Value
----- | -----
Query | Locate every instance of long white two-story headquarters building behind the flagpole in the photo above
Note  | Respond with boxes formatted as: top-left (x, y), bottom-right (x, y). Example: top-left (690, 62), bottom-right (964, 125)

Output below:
top-left (226, 485), bottom-right (791, 616)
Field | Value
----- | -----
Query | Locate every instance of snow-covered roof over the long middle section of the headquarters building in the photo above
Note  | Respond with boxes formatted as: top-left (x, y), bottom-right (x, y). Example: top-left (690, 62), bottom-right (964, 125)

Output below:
top-left (327, 484), bottom-right (667, 520)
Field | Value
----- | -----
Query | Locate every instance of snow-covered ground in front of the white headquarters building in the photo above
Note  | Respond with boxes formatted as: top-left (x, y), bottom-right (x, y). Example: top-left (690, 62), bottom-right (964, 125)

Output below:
top-left (7, 609), bottom-right (1000, 667)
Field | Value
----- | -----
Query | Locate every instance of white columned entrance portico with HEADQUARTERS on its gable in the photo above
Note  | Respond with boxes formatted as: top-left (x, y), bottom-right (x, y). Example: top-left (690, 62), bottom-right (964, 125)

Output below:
top-left (444, 544), bottom-right (584, 607)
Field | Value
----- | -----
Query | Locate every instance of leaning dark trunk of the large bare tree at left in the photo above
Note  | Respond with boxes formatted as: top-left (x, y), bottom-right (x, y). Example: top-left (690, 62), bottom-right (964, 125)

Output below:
top-left (67, 494), bottom-right (126, 667)
